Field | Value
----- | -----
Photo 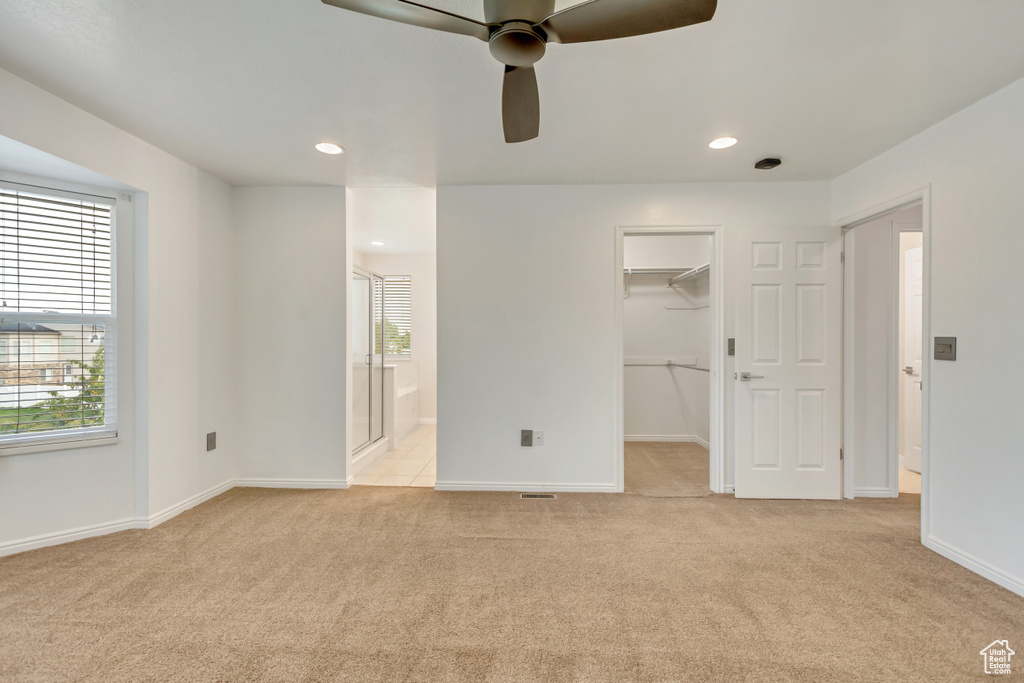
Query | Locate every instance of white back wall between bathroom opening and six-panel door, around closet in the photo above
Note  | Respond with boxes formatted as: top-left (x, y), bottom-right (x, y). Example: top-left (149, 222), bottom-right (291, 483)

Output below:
top-left (437, 182), bottom-right (829, 490)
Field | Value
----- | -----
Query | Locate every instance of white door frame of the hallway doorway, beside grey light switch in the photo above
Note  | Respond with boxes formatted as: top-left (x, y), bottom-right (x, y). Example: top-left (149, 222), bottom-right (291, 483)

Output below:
top-left (833, 184), bottom-right (932, 540)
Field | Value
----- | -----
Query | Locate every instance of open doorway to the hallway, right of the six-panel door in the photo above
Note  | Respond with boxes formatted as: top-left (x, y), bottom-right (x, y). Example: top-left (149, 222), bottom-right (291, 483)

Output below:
top-left (844, 202), bottom-right (926, 498)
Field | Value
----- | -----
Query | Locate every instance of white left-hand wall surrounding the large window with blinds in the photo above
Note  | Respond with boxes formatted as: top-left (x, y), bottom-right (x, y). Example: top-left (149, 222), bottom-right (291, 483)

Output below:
top-left (0, 71), bottom-right (237, 548)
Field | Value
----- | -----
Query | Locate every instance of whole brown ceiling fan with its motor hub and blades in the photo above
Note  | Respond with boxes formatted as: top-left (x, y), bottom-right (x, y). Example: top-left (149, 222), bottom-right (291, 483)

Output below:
top-left (323, 0), bottom-right (718, 142)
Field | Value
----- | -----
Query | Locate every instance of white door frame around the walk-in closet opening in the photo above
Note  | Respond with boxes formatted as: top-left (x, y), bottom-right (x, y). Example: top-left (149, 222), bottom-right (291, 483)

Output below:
top-left (611, 225), bottom-right (726, 494)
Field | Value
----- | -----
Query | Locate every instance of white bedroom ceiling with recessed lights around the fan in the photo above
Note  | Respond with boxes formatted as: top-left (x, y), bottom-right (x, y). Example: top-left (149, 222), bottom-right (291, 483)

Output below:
top-left (0, 0), bottom-right (1024, 186)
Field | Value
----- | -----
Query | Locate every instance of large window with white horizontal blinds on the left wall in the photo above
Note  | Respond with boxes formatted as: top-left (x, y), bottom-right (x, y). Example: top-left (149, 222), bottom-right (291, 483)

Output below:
top-left (0, 183), bottom-right (117, 447)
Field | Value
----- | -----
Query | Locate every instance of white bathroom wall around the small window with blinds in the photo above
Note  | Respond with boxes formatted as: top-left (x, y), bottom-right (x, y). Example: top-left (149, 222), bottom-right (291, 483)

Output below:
top-left (362, 254), bottom-right (437, 420)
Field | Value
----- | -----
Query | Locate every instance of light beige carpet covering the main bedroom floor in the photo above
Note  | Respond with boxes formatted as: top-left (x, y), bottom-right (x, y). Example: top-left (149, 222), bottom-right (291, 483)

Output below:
top-left (0, 486), bottom-right (1024, 682)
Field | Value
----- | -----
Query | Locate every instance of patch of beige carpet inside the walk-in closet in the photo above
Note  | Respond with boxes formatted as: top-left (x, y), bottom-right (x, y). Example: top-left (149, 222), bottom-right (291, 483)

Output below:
top-left (625, 441), bottom-right (711, 498)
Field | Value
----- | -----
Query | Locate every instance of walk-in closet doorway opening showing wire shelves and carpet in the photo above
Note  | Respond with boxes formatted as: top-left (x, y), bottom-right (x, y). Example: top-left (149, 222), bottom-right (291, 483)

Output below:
top-left (616, 228), bottom-right (724, 498)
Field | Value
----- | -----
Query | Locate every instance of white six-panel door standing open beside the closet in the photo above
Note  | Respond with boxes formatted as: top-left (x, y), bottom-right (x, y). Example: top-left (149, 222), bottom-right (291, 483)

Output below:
top-left (734, 228), bottom-right (843, 499)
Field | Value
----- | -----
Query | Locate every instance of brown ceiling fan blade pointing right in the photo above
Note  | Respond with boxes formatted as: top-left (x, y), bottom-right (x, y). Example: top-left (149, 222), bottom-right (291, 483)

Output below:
top-left (540, 0), bottom-right (718, 43)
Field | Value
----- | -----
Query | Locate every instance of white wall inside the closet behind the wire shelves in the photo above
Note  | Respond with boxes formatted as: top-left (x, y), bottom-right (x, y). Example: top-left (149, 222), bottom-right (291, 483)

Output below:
top-left (623, 234), bottom-right (712, 446)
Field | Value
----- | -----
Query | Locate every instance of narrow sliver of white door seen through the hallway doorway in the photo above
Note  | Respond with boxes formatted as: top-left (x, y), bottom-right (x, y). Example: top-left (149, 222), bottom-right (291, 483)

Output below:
top-left (901, 247), bottom-right (924, 472)
